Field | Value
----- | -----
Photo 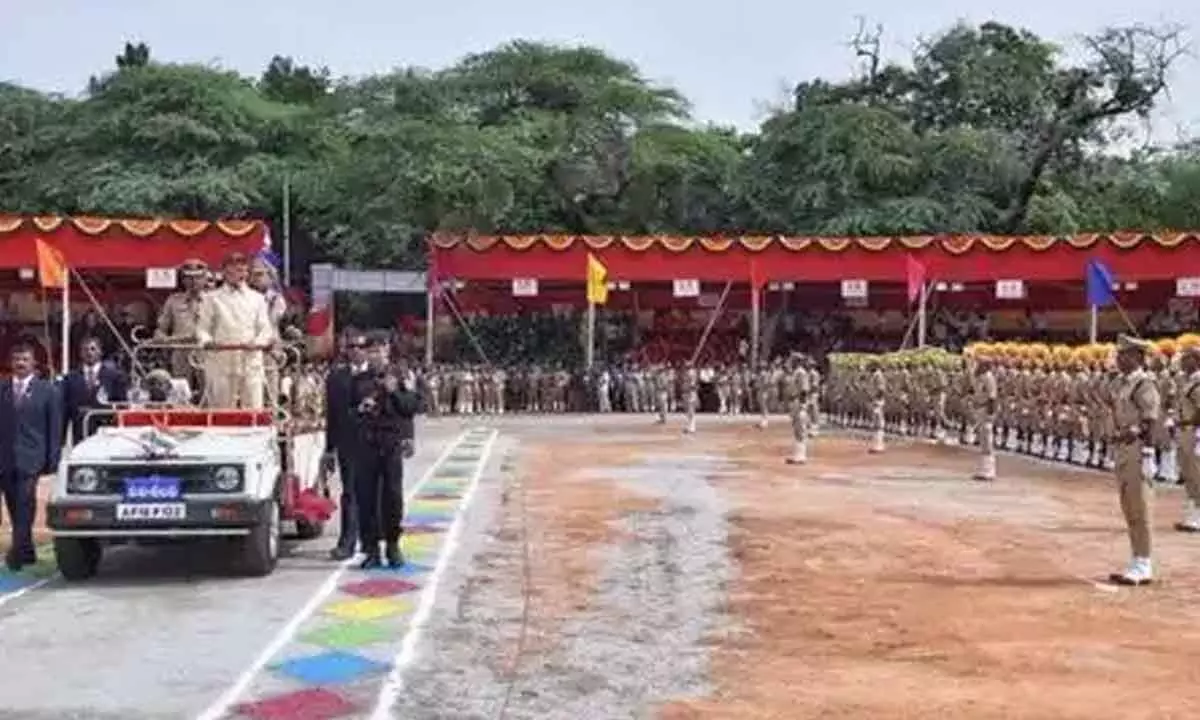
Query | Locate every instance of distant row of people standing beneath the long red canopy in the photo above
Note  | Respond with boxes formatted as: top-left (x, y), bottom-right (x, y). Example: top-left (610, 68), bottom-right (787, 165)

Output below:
top-left (418, 359), bottom-right (822, 415)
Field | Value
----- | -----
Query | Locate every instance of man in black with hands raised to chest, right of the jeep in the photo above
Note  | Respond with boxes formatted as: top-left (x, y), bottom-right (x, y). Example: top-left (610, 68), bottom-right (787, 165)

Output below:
top-left (352, 337), bottom-right (421, 569)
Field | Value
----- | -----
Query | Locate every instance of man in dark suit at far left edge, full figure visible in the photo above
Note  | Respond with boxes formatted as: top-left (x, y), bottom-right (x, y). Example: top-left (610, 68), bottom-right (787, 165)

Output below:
top-left (0, 344), bottom-right (62, 571)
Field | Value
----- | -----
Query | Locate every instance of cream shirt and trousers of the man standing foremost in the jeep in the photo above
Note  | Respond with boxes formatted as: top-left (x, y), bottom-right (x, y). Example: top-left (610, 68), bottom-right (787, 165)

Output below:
top-left (196, 286), bottom-right (275, 408)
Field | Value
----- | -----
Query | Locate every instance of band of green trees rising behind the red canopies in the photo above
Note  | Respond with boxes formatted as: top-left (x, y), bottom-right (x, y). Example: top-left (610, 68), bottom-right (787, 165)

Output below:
top-left (0, 23), bottom-right (1200, 268)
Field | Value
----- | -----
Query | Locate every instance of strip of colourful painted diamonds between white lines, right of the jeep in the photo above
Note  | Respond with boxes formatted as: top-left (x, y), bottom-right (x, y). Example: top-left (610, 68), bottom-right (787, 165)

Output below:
top-left (229, 428), bottom-right (496, 720)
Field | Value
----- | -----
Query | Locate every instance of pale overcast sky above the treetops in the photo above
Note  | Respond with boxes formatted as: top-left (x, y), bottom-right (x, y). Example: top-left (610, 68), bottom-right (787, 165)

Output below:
top-left (0, 0), bottom-right (1200, 139)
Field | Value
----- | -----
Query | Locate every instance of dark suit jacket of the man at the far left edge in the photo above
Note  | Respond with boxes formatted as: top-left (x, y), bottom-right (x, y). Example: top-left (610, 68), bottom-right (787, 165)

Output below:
top-left (0, 378), bottom-right (62, 476)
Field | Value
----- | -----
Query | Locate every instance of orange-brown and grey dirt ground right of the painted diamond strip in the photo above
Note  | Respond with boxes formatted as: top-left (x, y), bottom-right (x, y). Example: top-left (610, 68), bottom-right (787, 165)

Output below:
top-left (397, 419), bottom-right (1200, 720)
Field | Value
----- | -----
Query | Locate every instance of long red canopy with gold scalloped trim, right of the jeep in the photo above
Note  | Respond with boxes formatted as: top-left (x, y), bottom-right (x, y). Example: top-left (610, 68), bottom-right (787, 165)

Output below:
top-left (430, 232), bottom-right (1200, 360)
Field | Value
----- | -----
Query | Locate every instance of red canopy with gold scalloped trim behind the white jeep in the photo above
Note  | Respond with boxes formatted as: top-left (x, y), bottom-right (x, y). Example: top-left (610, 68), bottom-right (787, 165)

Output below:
top-left (0, 214), bottom-right (269, 367)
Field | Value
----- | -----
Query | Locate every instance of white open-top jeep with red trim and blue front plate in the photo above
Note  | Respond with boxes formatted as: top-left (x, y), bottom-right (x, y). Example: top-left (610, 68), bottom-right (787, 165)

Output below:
top-left (47, 340), bottom-right (334, 580)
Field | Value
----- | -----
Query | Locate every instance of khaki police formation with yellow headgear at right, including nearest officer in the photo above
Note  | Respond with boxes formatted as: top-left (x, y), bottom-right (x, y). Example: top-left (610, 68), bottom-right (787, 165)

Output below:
top-left (826, 334), bottom-right (1200, 586)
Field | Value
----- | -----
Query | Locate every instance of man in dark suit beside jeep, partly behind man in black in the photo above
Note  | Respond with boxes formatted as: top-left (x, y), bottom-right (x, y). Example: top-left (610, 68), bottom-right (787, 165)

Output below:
top-left (324, 334), bottom-right (367, 560)
